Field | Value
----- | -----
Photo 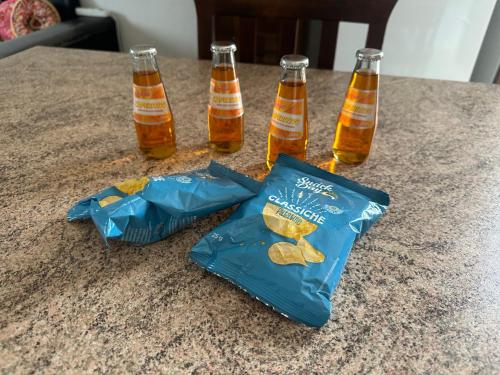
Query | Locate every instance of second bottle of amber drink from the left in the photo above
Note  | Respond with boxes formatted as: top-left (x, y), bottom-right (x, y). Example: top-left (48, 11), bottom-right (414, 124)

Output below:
top-left (208, 42), bottom-right (243, 153)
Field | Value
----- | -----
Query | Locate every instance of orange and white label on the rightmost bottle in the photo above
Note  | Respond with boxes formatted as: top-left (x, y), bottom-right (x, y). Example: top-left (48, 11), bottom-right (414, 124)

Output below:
top-left (339, 87), bottom-right (377, 128)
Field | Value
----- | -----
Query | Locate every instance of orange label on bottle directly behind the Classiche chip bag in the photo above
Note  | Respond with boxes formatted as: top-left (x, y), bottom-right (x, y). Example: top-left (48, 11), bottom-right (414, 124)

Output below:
top-left (269, 96), bottom-right (304, 140)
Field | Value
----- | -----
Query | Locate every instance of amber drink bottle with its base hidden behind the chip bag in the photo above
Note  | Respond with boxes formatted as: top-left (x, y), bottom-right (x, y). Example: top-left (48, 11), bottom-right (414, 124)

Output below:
top-left (267, 55), bottom-right (309, 169)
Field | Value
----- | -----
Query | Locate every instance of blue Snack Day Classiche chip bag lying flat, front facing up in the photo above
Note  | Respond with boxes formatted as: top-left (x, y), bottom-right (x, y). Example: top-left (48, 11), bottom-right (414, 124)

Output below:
top-left (190, 155), bottom-right (389, 327)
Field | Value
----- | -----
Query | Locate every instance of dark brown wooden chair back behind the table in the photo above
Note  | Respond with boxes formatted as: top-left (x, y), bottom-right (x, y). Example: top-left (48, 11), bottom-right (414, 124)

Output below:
top-left (195, 0), bottom-right (397, 69)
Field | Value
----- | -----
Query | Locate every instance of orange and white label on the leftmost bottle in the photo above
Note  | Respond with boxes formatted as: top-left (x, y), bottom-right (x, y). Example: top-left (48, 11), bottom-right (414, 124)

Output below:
top-left (134, 83), bottom-right (172, 125)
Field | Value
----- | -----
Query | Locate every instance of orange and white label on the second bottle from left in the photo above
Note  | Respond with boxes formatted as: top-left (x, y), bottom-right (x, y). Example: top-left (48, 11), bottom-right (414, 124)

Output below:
top-left (208, 78), bottom-right (243, 119)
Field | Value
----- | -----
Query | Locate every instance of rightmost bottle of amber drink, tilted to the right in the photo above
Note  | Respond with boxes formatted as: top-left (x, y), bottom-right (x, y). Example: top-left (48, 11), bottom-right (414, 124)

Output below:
top-left (333, 48), bottom-right (383, 165)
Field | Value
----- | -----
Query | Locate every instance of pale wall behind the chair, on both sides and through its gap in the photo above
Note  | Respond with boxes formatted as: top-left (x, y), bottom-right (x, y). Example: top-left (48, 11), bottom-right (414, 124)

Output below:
top-left (81, 0), bottom-right (496, 81)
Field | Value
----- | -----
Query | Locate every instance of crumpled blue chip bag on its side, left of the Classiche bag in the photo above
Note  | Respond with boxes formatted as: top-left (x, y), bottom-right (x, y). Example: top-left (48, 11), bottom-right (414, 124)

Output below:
top-left (68, 161), bottom-right (260, 244)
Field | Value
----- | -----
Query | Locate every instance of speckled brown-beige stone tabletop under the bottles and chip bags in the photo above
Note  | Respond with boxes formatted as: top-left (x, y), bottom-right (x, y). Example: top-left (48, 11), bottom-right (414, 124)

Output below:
top-left (0, 47), bottom-right (500, 374)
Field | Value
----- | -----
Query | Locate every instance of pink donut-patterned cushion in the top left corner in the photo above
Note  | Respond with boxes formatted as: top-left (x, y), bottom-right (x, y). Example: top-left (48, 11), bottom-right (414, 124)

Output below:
top-left (0, 0), bottom-right (61, 40)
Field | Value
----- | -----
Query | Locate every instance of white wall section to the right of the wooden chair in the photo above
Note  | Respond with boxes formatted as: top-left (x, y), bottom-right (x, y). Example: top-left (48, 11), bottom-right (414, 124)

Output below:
top-left (382, 0), bottom-right (496, 81)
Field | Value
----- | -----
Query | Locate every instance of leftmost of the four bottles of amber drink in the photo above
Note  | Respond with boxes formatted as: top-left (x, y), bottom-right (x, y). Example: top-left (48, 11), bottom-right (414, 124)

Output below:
top-left (130, 45), bottom-right (175, 159)
